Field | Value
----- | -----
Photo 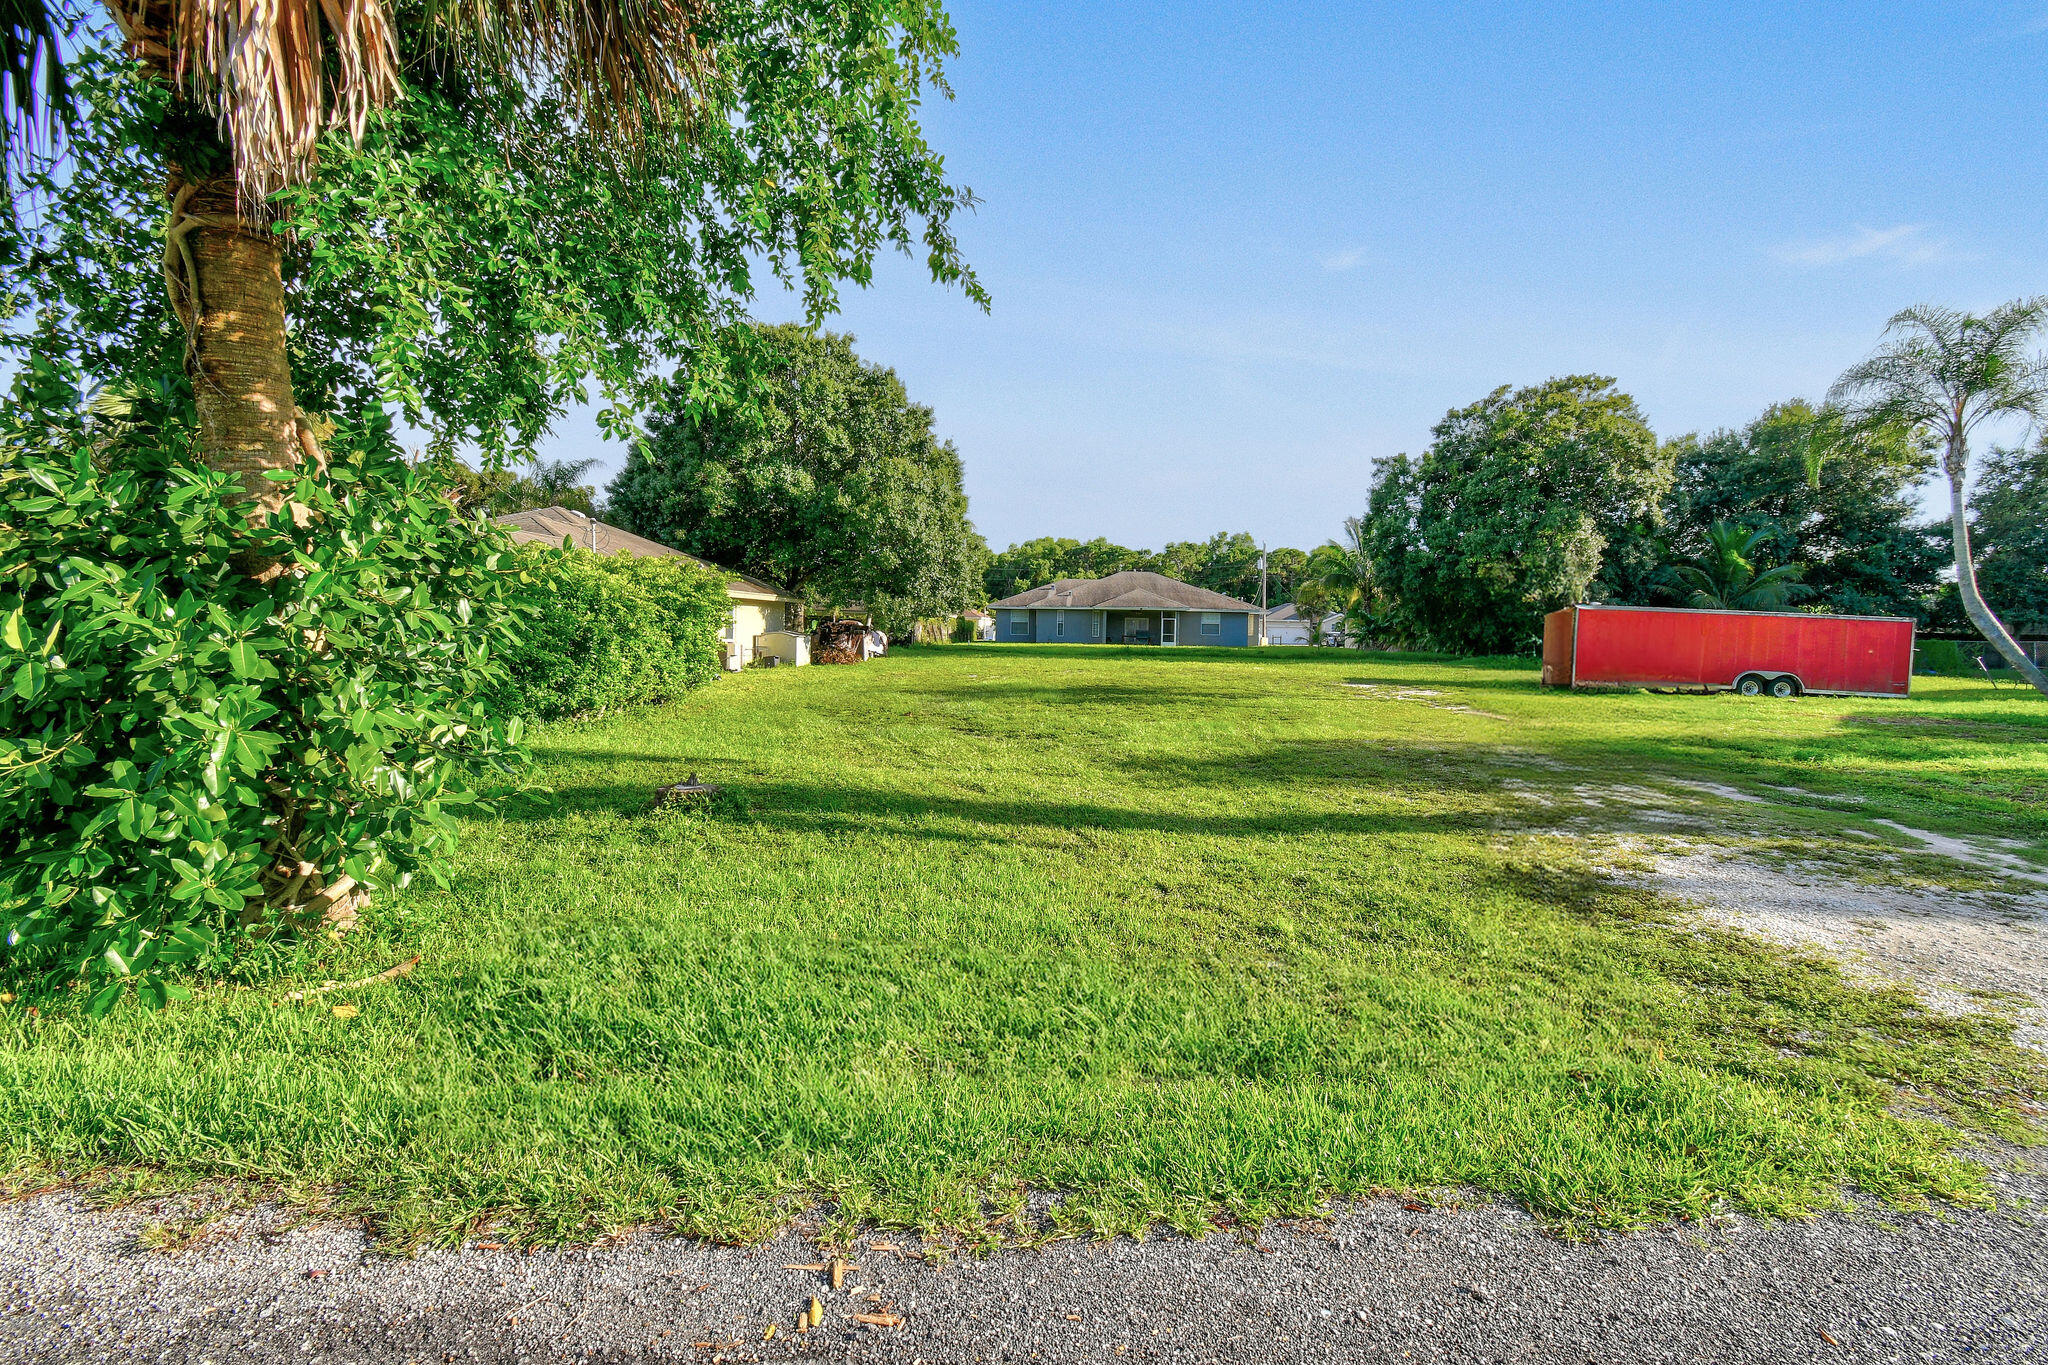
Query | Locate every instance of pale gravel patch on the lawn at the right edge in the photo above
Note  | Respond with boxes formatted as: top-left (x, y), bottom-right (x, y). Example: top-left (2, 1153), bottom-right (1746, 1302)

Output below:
top-left (1649, 845), bottom-right (2048, 1052)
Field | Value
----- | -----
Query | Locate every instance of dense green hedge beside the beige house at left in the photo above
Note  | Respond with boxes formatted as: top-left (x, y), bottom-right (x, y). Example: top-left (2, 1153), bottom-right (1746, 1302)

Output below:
top-left (504, 544), bottom-right (731, 720)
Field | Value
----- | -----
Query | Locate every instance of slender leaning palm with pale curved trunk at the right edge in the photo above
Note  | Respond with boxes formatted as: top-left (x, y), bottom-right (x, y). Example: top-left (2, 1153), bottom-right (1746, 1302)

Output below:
top-left (1827, 297), bottom-right (2048, 694)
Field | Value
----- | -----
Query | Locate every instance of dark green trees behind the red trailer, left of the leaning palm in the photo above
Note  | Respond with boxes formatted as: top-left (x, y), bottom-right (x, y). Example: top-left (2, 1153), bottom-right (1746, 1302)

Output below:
top-left (1662, 399), bottom-right (1944, 616)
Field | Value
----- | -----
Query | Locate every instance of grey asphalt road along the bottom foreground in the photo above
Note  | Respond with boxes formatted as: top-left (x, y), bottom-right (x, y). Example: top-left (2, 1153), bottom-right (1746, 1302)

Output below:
top-left (0, 1154), bottom-right (2048, 1365)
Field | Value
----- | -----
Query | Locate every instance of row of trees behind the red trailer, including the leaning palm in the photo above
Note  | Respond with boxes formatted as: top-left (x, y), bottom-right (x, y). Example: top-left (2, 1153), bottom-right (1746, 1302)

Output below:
top-left (1323, 311), bottom-right (2048, 695)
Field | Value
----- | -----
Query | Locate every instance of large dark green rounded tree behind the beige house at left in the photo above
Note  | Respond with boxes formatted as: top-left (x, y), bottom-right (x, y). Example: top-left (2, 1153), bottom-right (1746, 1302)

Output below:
top-left (606, 325), bottom-right (987, 618)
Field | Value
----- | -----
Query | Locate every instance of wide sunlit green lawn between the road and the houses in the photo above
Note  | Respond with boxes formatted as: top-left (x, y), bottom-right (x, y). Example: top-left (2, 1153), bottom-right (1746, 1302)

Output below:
top-left (0, 645), bottom-right (2048, 1244)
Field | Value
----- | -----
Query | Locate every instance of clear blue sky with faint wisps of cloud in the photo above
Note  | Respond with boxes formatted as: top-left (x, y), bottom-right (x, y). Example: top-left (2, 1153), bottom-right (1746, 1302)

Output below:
top-left (545, 0), bottom-right (2048, 548)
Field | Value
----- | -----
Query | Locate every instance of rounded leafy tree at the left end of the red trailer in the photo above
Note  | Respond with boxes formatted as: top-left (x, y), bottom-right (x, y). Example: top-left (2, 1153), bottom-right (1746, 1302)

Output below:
top-left (1360, 375), bottom-right (1673, 653)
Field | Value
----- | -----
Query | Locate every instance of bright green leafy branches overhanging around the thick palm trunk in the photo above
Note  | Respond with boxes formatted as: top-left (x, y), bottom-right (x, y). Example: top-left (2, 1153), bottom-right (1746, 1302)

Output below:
top-left (8, 0), bottom-right (983, 463)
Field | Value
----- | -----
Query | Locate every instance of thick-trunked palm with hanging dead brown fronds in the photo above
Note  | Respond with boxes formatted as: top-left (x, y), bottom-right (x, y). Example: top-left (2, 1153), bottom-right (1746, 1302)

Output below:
top-left (0, 0), bottom-right (713, 514)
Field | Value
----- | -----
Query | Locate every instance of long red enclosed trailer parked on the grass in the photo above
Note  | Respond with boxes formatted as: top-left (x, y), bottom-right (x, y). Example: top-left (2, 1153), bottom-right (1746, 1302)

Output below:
top-left (1542, 606), bottom-right (1913, 696)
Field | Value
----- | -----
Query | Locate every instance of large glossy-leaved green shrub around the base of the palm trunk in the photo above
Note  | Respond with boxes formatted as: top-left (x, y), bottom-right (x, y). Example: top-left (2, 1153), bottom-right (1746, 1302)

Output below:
top-left (0, 424), bottom-right (524, 1011)
